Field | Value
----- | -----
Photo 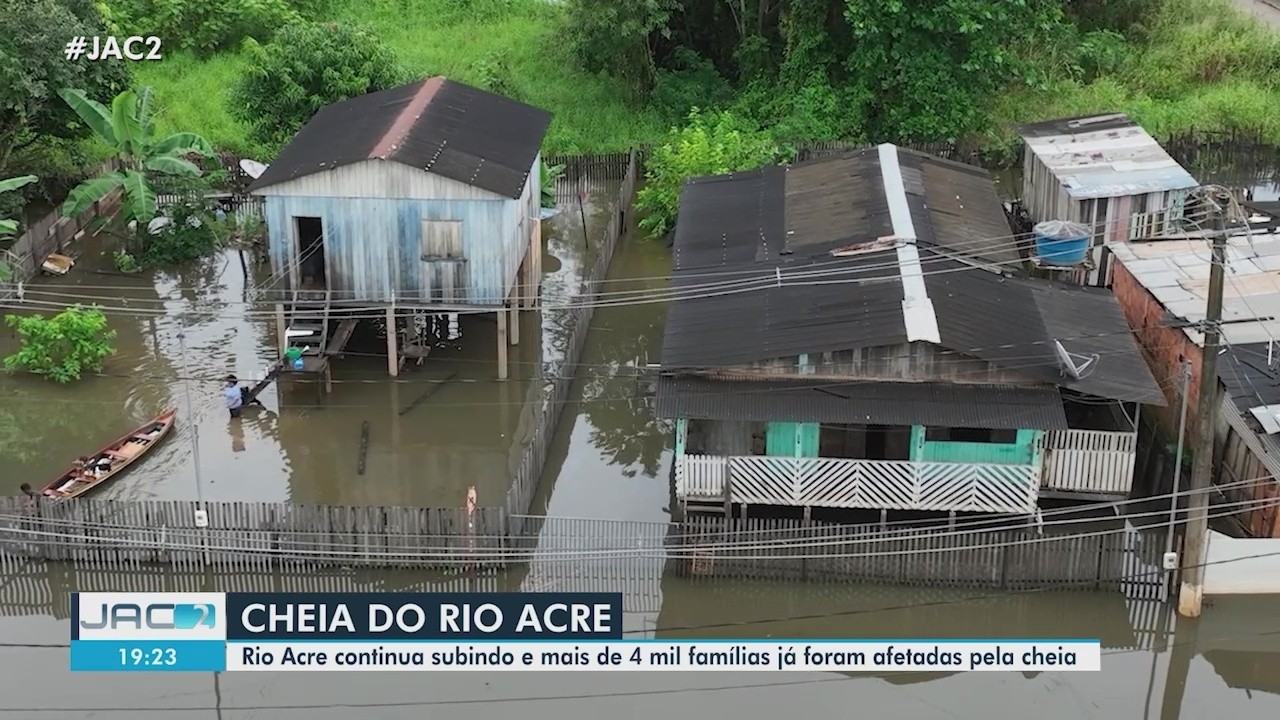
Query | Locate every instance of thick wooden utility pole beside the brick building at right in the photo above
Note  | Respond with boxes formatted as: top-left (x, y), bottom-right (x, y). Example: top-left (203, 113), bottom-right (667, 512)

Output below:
top-left (1178, 188), bottom-right (1231, 618)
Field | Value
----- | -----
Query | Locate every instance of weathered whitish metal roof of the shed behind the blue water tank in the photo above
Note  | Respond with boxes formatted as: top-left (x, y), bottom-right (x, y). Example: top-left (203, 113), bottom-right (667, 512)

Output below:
top-left (1018, 114), bottom-right (1199, 200)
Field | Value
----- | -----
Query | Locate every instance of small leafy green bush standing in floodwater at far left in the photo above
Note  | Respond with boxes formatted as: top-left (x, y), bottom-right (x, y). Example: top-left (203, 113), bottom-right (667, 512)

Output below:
top-left (4, 306), bottom-right (115, 383)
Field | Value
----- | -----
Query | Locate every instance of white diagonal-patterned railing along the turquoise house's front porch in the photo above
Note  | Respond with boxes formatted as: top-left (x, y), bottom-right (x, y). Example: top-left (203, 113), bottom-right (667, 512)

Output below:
top-left (676, 455), bottom-right (1039, 514)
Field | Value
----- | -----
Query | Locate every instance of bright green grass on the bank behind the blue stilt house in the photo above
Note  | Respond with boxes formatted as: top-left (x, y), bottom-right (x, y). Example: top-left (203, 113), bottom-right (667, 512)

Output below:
top-left (137, 0), bottom-right (666, 152)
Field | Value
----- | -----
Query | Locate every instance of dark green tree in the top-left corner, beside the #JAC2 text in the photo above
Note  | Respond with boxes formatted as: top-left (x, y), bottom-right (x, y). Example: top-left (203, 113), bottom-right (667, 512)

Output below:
top-left (0, 0), bottom-right (129, 174)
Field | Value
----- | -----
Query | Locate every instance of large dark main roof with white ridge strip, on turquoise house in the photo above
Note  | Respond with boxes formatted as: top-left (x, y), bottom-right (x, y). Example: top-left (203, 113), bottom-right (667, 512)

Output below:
top-left (662, 145), bottom-right (1165, 405)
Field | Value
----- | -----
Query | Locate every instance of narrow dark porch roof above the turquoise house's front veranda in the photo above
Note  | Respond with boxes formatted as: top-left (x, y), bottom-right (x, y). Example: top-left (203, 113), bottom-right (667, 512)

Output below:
top-left (657, 375), bottom-right (1066, 430)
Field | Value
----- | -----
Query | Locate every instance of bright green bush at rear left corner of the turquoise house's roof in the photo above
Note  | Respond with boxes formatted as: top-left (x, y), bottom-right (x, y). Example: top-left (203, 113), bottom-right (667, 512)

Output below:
top-left (636, 108), bottom-right (785, 237)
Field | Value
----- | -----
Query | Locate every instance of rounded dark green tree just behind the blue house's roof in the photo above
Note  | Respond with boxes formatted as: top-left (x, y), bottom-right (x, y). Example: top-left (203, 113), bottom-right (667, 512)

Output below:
top-left (232, 23), bottom-right (407, 147)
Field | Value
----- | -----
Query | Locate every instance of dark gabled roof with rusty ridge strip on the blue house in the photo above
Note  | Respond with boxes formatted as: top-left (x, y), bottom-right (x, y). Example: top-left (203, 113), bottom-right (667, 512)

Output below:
top-left (250, 77), bottom-right (550, 199)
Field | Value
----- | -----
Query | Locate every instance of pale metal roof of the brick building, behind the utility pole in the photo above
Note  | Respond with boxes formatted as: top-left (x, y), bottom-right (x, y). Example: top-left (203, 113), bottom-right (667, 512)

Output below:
top-left (1108, 226), bottom-right (1280, 346)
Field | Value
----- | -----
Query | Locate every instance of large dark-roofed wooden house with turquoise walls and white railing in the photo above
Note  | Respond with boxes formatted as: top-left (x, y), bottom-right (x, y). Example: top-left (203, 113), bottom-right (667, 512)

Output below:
top-left (657, 145), bottom-right (1165, 514)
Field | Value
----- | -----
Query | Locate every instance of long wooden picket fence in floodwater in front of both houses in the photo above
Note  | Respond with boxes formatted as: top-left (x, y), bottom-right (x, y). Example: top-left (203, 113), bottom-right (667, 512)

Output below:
top-left (0, 489), bottom-right (1166, 602)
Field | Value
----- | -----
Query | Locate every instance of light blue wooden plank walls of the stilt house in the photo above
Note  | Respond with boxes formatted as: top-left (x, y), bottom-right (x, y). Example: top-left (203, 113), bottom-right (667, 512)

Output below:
top-left (264, 192), bottom-right (527, 306)
